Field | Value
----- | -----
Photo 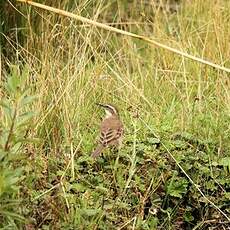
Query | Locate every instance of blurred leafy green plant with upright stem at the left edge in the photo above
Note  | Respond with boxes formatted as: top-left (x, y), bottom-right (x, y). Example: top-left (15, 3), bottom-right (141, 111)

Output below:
top-left (0, 66), bottom-right (35, 227)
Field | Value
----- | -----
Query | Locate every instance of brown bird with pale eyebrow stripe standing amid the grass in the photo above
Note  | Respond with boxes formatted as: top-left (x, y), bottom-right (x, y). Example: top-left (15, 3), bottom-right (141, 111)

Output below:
top-left (91, 103), bottom-right (124, 158)
